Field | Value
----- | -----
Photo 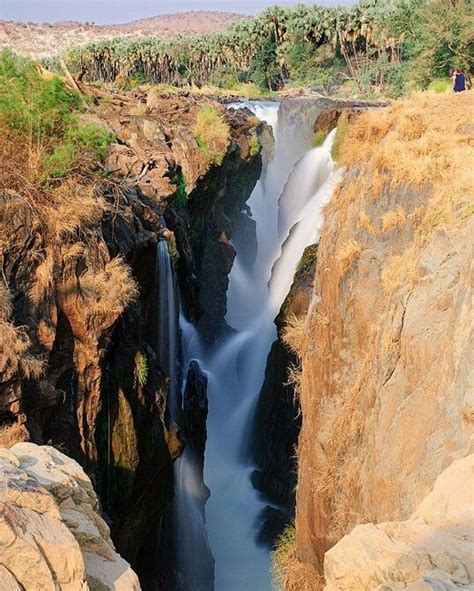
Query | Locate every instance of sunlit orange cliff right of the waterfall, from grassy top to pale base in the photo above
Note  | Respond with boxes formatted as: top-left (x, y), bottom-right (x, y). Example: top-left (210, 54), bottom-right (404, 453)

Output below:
top-left (283, 93), bottom-right (474, 590)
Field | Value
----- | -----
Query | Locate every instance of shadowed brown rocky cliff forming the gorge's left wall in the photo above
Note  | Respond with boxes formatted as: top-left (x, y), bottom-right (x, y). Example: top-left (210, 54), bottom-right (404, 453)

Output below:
top-left (0, 87), bottom-right (260, 588)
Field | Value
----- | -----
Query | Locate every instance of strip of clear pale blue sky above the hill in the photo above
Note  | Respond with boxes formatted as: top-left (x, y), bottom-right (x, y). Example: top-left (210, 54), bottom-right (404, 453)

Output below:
top-left (0, 0), bottom-right (356, 24)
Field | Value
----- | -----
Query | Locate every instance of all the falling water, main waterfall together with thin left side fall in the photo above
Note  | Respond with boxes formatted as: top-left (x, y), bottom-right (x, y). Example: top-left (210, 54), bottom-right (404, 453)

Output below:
top-left (158, 102), bottom-right (339, 591)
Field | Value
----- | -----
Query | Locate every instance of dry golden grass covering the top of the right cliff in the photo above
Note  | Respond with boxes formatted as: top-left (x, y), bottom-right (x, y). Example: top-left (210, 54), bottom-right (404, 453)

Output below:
top-left (334, 91), bottom-right (474, 295)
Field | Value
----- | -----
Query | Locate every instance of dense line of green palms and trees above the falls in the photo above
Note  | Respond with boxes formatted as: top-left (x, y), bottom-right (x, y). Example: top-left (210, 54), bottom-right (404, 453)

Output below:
top-left (62, 0), bottom-right (473, 94)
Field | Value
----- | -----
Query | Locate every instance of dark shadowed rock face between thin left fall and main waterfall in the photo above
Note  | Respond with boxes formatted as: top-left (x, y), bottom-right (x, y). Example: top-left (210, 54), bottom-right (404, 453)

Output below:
top-left (165, 116), bottom-right (262, 345)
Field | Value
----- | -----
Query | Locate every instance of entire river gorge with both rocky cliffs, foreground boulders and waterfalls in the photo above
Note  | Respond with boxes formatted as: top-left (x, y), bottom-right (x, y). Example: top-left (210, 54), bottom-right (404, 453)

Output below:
top-left (0, 85), bottom-right (474, 591)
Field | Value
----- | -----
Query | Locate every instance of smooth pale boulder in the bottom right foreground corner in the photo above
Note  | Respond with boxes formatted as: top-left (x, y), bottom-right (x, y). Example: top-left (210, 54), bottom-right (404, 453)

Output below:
top-left (324, 455), bottom-right (474, 591)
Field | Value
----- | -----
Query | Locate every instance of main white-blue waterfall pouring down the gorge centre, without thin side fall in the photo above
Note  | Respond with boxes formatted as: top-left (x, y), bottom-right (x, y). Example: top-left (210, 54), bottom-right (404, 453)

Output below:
top-left (201, 102), bottom-right (339, 591)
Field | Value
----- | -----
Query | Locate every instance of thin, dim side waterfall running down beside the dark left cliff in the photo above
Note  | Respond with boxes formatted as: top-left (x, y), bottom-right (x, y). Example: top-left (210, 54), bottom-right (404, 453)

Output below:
top-left (155, 240), bottom-right (213, 591)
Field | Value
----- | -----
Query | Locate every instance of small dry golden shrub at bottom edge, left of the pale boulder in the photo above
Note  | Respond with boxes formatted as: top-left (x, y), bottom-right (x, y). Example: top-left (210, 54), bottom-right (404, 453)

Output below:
top-left (272, 526), bottom-right (324, 591)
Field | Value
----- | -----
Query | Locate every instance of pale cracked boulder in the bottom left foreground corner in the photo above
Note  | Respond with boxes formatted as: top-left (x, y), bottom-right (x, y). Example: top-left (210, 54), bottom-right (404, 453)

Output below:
top-left (0, 443), bottom-right (140, 591)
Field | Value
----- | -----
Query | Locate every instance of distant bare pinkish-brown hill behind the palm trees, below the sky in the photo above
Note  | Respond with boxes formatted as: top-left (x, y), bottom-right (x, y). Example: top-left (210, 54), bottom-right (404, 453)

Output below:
top-left (0, 11), bottom-right (247, 57)
